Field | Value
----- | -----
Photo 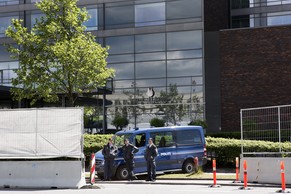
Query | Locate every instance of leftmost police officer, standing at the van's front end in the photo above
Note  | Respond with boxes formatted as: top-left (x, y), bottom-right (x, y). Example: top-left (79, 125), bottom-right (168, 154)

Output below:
top-left (102, 138), bottom-right (117, 181)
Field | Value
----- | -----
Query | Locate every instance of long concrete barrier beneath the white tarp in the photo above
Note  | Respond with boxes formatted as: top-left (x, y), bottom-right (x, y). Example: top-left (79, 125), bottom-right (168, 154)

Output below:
top-left (0, 160), bottom-right (86, 188)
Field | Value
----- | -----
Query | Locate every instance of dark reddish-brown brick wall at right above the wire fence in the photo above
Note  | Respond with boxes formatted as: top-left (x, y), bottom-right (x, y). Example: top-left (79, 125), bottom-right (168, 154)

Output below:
top-left (220, 26), bottom-right (291, 131)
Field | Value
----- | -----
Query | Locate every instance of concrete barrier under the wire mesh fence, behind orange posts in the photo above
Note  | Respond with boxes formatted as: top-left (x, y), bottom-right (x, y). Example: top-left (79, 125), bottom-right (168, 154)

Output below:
top-left (240, 157), bottom-right (291, 184)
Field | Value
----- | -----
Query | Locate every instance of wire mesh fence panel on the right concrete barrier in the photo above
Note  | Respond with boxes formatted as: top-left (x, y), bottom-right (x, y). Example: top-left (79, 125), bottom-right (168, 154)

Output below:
top-left (240, 105), bottom-right (291, 156)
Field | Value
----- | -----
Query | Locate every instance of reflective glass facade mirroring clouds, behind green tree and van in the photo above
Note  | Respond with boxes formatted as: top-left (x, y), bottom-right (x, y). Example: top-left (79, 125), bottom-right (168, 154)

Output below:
top-left (0, 0), bottom-right (204, 128)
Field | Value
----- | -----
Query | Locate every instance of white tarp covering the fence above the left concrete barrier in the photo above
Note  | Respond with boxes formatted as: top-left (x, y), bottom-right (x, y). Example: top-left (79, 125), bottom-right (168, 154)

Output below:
top-left (0, 108), bottom-right (83, 159)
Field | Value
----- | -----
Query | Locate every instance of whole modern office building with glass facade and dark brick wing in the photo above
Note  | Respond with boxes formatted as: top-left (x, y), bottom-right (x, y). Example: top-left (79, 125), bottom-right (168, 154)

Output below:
top-left (0, 0), bottom-right (291, 132)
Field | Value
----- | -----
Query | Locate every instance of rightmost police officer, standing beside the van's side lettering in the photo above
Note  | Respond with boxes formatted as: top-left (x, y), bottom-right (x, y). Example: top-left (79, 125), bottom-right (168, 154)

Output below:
top-left (144, 138), bottom-right (158, 181)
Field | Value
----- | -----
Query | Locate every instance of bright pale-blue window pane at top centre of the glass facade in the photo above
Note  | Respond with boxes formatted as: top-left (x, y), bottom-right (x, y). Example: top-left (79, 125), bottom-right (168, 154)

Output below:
top-left (135, 2), bottom-right (166, 26)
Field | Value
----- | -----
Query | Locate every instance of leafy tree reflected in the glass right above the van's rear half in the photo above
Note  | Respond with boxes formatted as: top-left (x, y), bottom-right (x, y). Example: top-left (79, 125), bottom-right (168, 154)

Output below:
top-left (157, 84), bottom-right (186, 125)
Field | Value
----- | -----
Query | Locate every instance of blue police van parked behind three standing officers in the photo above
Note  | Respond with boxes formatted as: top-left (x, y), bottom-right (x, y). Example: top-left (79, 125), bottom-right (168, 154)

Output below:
top-left (95, 126), bottom-right (206, 180)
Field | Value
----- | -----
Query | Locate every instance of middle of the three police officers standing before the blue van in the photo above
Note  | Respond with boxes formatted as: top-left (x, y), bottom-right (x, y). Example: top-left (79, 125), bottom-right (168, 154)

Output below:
top-left (122, 139), bottom-right (139, 181)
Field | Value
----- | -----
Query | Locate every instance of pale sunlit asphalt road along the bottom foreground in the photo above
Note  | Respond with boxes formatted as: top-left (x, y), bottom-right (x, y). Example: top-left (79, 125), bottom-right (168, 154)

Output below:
top-left (0, 182), bottom-right (291, 194)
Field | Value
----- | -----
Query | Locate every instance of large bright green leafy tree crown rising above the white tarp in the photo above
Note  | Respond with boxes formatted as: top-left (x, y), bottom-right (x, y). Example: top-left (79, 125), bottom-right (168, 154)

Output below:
top-left (6, 0), bottom-right (114, 106)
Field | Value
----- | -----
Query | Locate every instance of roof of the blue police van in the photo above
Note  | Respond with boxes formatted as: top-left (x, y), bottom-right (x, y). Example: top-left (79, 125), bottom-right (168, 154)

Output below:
top-left (116, 125), bottom-right (203, 134)
